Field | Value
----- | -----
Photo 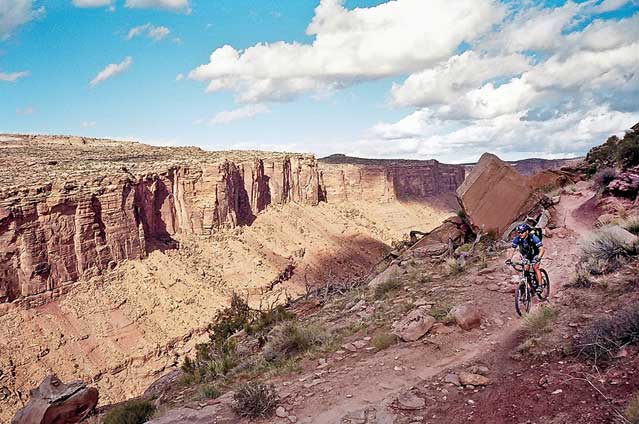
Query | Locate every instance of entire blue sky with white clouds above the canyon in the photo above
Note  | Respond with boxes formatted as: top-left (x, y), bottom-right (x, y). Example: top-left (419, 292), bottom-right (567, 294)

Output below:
top-left (0, 0), bottom-right (639, 162)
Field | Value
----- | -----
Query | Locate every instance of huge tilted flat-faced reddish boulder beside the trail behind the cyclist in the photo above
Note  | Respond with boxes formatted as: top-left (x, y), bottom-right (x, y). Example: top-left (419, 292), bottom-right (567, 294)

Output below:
top-left (457, 153), bottom-right (538, 235)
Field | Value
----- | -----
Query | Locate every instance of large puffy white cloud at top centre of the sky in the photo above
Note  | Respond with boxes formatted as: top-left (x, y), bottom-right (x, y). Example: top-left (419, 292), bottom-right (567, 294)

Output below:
top-left (189, 0), bottom-right (504, 102)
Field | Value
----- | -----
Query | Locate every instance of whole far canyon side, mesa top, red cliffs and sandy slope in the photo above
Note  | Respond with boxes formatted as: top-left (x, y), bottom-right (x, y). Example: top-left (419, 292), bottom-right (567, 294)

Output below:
top-left (0, 135), bottom-right (465, 419)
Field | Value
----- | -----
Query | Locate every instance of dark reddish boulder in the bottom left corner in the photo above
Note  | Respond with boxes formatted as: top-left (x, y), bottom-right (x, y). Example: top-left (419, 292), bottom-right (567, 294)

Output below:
top-left (11, 375), bottom-right (98, 424)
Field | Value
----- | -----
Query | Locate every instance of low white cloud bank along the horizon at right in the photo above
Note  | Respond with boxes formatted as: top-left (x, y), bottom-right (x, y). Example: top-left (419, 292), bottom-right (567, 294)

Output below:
top-left (360, 106), bottom-right (639, 163)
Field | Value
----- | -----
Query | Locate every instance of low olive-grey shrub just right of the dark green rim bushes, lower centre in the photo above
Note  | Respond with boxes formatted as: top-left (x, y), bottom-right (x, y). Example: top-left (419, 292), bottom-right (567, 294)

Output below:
top-left (264, 321), bottom-right (328, 361)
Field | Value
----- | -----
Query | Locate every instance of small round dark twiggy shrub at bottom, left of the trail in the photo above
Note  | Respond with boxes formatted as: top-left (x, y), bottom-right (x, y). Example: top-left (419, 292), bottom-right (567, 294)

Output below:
top-left (233, 382), bottom-right (280, 418)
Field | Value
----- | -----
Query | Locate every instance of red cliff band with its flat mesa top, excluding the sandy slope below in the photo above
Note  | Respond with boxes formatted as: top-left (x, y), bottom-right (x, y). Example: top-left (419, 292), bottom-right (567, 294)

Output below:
top-left (0, 136), bottom-right (464, 304)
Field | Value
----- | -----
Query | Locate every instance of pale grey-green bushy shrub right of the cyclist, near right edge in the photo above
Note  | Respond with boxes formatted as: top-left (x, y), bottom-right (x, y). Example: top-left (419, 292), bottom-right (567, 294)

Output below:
top-left (580, 227), bottom-right (634, 273)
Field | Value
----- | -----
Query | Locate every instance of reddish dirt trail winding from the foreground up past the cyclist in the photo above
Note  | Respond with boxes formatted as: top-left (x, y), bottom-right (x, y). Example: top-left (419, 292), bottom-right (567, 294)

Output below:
top-left (262, 184), bottom-right (594, 424)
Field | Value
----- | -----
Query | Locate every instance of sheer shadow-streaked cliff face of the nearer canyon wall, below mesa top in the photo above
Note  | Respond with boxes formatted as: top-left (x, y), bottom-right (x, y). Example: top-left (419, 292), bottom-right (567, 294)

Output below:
top-left (0, 156), bottom-right (320, 302)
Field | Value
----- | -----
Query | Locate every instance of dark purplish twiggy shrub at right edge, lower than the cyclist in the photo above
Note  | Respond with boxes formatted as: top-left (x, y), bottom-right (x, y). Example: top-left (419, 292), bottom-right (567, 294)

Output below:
top-left (575, 302), bottom-right (639, 361)
